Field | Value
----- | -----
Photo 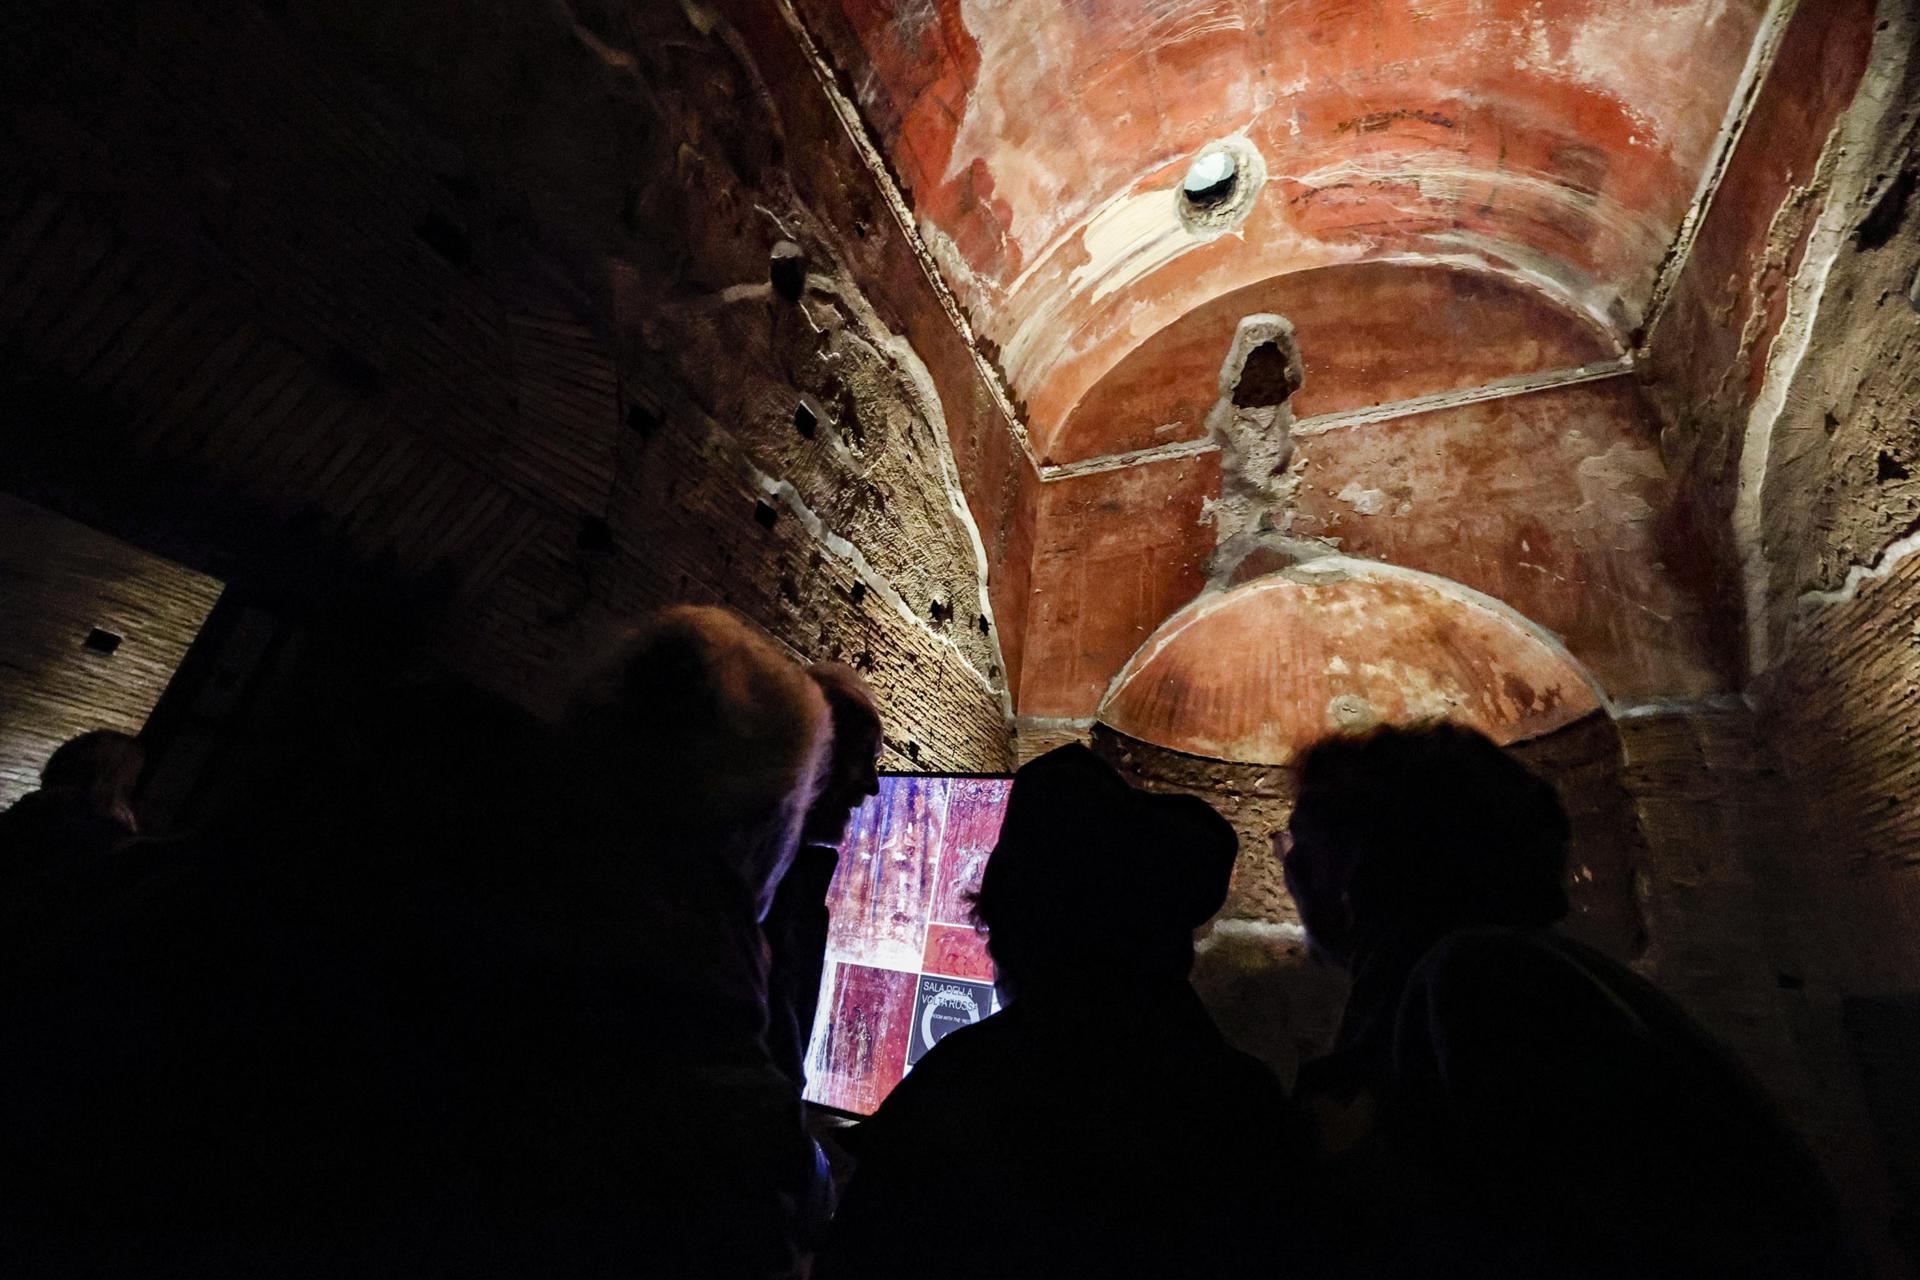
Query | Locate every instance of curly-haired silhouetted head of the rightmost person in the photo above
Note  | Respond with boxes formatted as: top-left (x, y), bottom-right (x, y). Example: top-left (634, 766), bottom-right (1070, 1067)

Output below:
top-left (1275, 723), bottom-right (1569, 967)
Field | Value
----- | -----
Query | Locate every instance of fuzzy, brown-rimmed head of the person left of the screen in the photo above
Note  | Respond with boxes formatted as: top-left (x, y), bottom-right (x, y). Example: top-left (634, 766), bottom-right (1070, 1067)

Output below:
top-left (568, 604), bottom-right (828, 917)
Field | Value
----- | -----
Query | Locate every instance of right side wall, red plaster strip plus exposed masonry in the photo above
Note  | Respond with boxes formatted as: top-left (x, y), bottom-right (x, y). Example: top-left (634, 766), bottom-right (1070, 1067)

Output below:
top-left (1645, 0), bottom-right (1920, 1265)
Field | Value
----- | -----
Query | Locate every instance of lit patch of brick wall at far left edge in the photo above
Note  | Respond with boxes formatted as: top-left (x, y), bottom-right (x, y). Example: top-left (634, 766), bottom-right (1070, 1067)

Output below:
top-left (0, 495), bottom-right (221, 808)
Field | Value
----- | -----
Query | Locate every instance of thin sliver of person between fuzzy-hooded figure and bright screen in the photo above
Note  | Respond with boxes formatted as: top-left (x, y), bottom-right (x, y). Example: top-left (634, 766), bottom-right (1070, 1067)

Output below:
top-left (764, 662), bottom-right (881, 1088)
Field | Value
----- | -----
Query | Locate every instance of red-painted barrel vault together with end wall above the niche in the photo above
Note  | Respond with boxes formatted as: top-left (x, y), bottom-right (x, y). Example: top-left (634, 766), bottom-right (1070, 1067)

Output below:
top-left (793, 0), bottom-right (1791, 745)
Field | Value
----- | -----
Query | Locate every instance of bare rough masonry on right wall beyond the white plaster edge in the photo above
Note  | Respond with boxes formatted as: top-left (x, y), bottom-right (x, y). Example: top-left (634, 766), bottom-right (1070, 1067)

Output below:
top-left (1747, 0), bottom-right (1920, 994)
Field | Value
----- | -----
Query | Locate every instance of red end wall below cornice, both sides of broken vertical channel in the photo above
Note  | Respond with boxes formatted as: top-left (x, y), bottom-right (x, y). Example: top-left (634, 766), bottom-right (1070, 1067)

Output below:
top-left (1018, 378), bottom-right (1732, 718)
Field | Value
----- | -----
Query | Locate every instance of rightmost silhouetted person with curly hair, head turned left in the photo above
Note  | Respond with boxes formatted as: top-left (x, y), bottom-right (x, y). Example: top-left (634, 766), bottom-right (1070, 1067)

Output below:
top-left (1277, 723), bottom-right (1851, 1280)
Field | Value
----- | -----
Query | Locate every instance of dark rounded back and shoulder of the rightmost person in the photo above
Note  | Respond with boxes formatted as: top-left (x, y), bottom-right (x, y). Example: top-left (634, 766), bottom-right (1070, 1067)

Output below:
top-left (1394, 929), bottom-right (1851, 1276)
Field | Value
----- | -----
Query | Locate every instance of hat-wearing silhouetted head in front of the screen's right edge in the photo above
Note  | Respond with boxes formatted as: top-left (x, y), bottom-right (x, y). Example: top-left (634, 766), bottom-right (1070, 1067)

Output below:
top-left (973, 743), bottom-right (1238, 994)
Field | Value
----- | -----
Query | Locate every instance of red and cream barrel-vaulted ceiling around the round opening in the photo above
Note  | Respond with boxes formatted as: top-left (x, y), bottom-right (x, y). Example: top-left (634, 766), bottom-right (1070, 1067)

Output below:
top-left (799, 0), bottom-right (1766, 437)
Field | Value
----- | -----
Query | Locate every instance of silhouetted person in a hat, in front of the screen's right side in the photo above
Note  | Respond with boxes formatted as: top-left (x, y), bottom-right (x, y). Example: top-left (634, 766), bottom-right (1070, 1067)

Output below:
top-left (816, 745), bottom-right (1284, 1280)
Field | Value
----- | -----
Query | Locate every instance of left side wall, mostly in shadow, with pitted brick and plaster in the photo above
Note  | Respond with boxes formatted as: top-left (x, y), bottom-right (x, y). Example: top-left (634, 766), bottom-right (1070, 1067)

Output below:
top-left (0, 0), bottom-right (1014, 770)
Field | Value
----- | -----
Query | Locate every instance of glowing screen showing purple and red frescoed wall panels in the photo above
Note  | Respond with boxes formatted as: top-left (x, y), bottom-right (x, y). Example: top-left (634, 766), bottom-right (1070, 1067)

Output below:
top-left (806, 775), bottom-right (1014, 1115)
